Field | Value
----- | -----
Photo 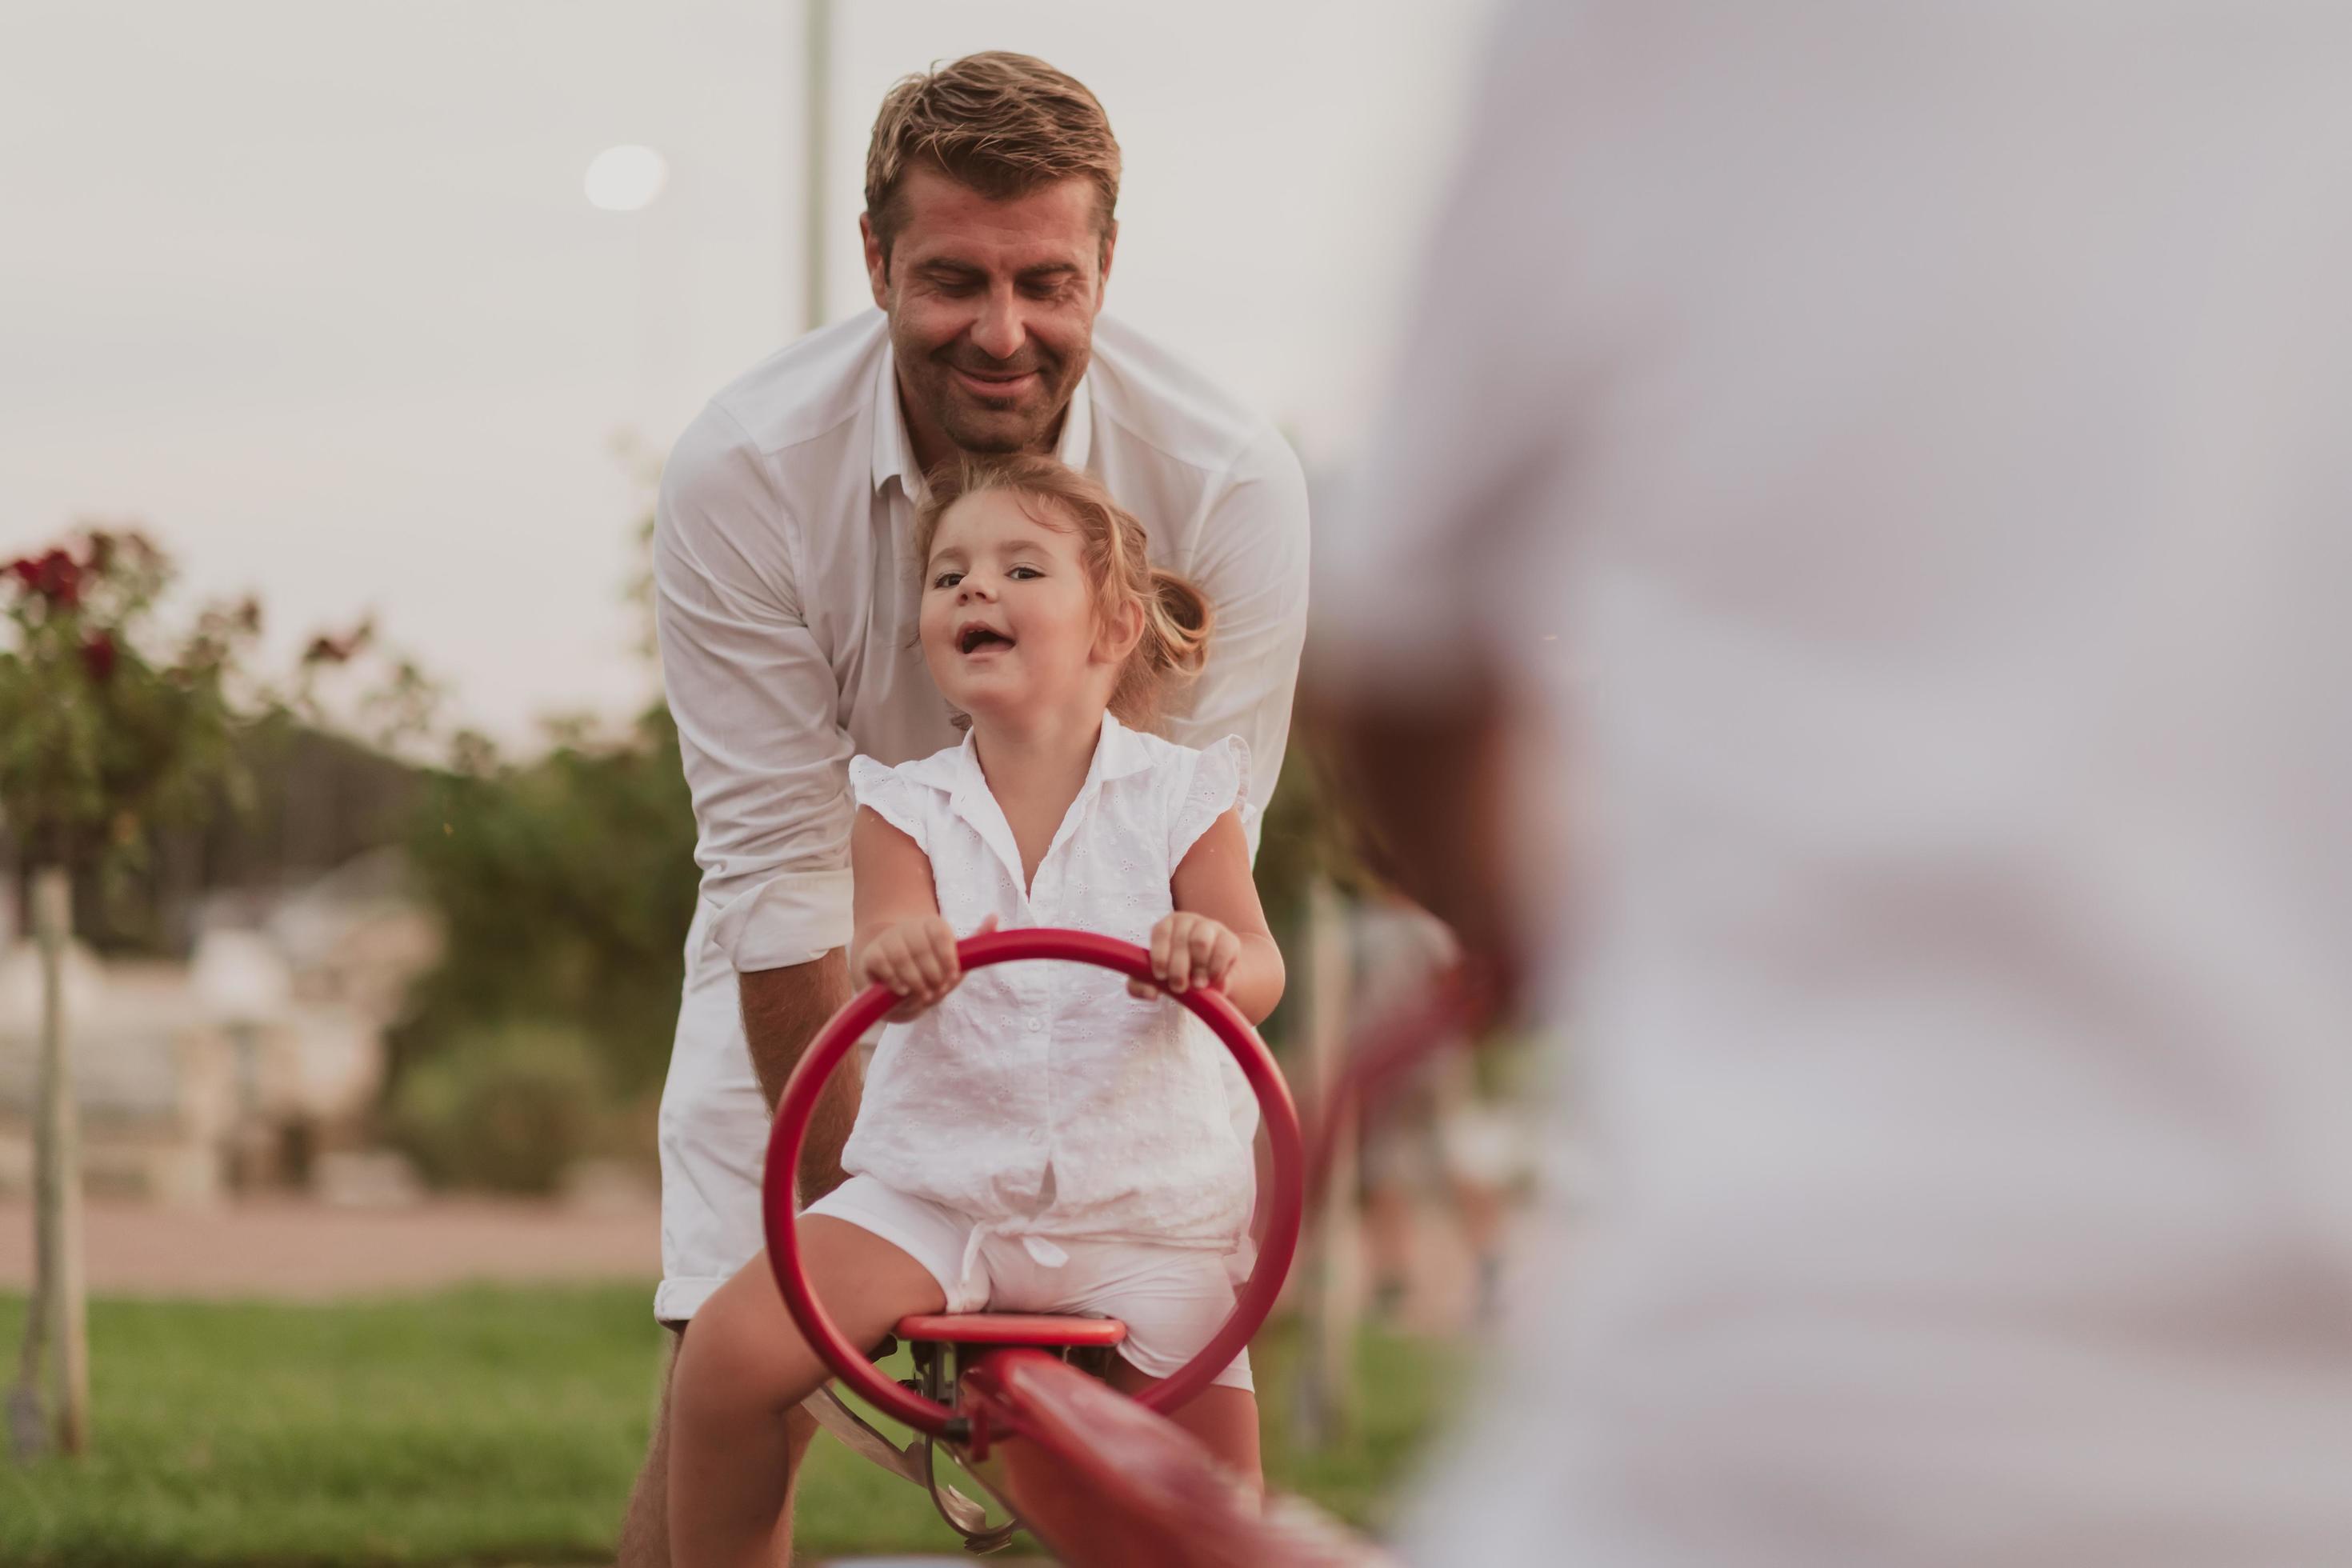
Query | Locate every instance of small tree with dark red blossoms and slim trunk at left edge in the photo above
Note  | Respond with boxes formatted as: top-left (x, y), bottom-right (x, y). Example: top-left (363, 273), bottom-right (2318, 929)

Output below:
top-left (0, 529), bottom-right (261, 1455)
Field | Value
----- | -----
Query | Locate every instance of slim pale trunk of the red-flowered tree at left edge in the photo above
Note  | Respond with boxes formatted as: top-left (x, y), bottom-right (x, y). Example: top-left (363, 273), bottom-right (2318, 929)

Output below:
top-left (10, 865), bottom-right (90, 1458)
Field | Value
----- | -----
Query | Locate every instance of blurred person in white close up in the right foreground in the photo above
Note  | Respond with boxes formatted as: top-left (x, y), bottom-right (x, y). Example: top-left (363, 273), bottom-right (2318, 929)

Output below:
top-left (1313, 0), bottom-right (2352, 1568)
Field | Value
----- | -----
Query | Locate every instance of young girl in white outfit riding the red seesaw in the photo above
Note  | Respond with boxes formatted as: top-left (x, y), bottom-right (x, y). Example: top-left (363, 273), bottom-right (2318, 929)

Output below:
top-left (670, 456), bottom-right (1282, 1568)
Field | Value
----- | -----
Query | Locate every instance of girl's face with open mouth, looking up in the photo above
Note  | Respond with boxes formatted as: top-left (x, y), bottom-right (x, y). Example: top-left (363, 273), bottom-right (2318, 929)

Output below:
top-left (918, 489), bottom-right (1141, 724)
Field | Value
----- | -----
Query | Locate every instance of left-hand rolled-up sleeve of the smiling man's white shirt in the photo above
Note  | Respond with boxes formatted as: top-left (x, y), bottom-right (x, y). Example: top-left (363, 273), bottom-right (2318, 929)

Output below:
top-left (654, 404), bottom-right (854, 971)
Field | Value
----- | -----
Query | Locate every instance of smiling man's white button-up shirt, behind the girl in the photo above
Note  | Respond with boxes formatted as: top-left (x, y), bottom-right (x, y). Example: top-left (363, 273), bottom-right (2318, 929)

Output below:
top-left (654, 310), bottom-right (1308, 971)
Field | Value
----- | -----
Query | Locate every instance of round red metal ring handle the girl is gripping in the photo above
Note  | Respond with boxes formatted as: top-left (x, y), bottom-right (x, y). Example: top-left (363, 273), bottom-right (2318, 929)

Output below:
top-left (765, 926), bottom-right (1306, 1436)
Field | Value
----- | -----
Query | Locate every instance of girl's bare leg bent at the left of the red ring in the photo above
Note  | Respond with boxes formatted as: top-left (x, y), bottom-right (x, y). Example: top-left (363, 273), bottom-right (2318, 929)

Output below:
top-left (668, 1215), bottom-right (946, 1568)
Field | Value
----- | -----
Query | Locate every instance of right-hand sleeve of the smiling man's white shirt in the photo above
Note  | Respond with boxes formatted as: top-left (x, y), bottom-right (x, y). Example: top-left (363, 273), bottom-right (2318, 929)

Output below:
top-left (1169, 426), bottom-right (1308, 832)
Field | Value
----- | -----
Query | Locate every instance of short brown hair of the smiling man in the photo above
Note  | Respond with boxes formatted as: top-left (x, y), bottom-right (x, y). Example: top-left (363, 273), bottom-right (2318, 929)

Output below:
top-left (866, 50), bottom-right (1119, 258)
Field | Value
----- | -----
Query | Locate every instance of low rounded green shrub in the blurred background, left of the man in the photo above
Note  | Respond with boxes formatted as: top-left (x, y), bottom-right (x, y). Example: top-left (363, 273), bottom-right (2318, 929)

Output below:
top-left (388, 1022), bottom-right (607, 1194)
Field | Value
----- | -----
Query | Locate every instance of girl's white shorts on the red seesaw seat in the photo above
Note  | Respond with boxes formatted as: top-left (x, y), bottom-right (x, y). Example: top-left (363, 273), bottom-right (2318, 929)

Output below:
top-left (806, 1175), bottom-right (1254, 1390)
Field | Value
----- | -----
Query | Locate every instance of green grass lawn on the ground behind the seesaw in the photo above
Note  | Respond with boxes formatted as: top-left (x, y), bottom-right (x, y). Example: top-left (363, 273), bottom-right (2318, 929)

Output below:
top-left (0, 1286), bottom-right (1456, 1566)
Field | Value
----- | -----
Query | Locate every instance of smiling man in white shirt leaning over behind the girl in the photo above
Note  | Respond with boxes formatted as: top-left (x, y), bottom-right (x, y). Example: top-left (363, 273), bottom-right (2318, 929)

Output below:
top-left (623, 54), bottom-right (1308, 1563)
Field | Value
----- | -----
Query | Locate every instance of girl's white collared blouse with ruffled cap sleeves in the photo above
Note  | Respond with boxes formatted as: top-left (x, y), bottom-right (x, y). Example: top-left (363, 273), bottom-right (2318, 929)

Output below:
top-left (842, 714), bottom-right (1256, 1246)
